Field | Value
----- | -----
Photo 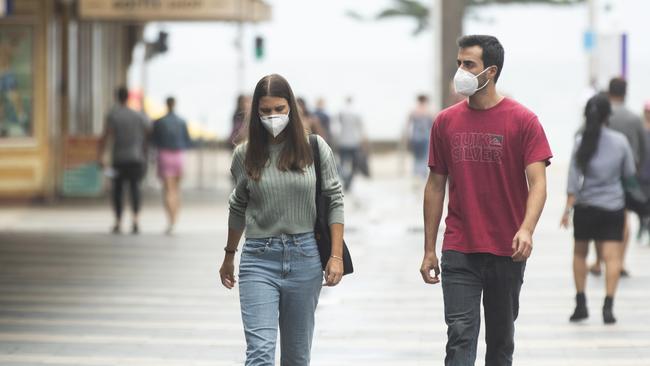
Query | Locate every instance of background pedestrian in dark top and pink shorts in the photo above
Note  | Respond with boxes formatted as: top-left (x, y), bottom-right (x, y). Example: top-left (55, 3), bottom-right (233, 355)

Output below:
top-left (152, 97), bottom-right (192, 235)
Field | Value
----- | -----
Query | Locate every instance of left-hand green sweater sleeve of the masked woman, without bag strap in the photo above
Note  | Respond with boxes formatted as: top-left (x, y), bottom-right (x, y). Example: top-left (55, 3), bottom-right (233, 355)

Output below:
top-left (228, 145), bottom-right (248, 231)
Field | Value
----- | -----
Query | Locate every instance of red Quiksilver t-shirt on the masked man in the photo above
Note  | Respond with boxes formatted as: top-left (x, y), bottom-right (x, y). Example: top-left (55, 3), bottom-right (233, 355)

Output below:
top-left (429, 98), bottom-right (553, 256)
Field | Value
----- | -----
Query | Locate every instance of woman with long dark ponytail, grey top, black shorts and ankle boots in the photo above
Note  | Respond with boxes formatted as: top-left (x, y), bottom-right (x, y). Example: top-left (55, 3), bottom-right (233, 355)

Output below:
top-left (561, 94), bottom-right (635, 324)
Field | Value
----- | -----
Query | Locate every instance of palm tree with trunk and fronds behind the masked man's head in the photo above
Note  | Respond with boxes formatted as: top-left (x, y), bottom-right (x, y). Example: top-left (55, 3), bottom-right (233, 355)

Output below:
top-left (360, 0), bottom-right (585, 106)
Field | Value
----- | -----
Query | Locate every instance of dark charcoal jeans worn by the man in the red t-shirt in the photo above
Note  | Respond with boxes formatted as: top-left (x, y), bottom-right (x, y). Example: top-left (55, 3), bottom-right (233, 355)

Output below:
top-left (441, 250), bottom-right (526, 366)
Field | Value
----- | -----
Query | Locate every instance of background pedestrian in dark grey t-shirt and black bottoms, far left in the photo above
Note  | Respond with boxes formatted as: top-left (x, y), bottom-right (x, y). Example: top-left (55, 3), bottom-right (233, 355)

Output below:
top-left (97, 87), bottom-right (149, 234)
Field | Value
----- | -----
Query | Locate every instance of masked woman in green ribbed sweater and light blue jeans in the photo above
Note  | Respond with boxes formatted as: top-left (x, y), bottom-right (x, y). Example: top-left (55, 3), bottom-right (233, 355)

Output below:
top-left (219, 74), bottom-right (343, 366)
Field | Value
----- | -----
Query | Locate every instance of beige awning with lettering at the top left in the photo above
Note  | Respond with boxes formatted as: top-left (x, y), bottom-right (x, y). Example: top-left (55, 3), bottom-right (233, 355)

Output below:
top-left (78, 0), bottom-right (271, 22)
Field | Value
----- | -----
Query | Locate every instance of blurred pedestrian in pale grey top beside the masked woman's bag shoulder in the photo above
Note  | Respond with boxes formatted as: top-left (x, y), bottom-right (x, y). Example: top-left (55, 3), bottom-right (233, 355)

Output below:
top-left (336, 97), bottom-right (367, 191)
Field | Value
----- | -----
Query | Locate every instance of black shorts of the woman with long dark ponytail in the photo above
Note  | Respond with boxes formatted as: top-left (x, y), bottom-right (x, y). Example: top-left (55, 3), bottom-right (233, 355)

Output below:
top-left (573, 205), bottom-right (625, 241)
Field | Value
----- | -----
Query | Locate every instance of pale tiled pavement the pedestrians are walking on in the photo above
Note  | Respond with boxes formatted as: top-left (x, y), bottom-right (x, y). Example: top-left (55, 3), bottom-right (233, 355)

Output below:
top-left (0, 158), bottom-right (650, 366)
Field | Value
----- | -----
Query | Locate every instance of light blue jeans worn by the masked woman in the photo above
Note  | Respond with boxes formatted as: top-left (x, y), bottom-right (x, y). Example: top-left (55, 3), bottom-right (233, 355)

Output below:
top-left (239, 232), bottom-right (323, 366)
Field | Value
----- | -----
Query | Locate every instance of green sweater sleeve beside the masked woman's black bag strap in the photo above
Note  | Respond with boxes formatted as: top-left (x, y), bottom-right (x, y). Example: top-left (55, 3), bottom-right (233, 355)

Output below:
top-left (317, 136), bottom-right (344, 225)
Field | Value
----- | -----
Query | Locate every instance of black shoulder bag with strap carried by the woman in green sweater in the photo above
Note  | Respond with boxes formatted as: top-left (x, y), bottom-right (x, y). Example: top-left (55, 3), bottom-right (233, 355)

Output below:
top-left (309, 135), bottom-right (354, 275)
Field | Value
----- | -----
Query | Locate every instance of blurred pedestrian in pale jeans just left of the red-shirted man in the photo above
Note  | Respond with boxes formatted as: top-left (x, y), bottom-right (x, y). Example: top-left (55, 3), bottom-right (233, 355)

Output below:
top-left (406, 95), bottom-right (433, 180)
